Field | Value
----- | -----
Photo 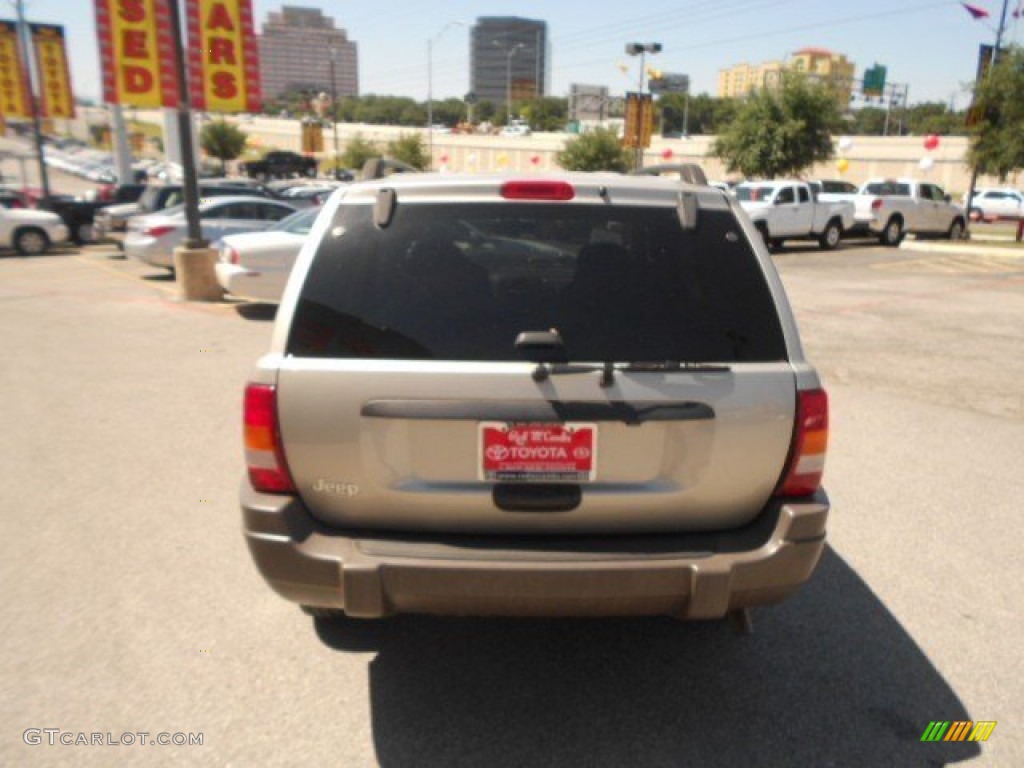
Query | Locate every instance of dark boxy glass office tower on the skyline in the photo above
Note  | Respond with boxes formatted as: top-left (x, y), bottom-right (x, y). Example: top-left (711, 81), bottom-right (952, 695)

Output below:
top-left (469, 16), bottom-right (551, 104)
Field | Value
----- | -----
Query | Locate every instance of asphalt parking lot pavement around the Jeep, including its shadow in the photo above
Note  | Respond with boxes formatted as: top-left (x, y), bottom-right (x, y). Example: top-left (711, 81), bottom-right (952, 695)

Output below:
top-left (0, 241), bottom-right (1024, 768)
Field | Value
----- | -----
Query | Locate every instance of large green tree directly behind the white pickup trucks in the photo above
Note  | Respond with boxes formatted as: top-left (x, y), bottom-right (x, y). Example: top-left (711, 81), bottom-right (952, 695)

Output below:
top-left (712, 74), bottom-right (841, 178)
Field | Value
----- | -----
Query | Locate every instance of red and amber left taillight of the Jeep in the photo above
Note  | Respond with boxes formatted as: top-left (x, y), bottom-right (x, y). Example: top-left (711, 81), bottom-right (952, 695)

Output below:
top-left (243, 384), bottom-right (295, 494)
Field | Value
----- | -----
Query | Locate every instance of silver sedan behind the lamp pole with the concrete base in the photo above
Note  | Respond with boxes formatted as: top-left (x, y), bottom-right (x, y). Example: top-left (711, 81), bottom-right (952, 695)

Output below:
top-left (125, 196), bottom-right (296, 269)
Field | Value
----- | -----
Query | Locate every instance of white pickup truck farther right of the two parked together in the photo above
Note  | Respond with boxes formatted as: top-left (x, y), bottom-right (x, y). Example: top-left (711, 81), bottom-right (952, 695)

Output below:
top-left (855, 178), bottom-right (967, 246)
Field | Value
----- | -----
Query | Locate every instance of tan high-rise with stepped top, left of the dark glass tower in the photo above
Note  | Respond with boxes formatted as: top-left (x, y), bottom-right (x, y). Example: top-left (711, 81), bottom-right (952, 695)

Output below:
top-left (259, 5), bottom-right (359, 98)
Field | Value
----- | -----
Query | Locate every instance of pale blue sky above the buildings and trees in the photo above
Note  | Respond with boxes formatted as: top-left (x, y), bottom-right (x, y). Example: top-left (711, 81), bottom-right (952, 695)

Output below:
top-left (19, 0), bottom-right (1024, 108)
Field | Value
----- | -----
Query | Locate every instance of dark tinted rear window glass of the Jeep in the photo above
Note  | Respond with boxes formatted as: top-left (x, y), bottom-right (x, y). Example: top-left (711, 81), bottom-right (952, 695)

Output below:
top-left (287, 203), bottom-right (785, 362)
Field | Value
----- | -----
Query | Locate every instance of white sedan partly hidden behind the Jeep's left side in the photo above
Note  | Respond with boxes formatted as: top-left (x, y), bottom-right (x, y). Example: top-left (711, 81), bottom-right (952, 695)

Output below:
top-left (216, 208), bottom-right (319, 304)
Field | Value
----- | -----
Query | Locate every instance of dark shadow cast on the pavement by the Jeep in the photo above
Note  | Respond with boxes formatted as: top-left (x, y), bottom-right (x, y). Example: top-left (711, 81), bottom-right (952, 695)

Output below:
top-left (316, 549), bottom-right (980, 768)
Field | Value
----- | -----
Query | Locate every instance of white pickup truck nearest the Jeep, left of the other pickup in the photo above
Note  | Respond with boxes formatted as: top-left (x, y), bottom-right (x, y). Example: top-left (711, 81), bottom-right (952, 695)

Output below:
top-left (734, 181), bottom-right (854, 250)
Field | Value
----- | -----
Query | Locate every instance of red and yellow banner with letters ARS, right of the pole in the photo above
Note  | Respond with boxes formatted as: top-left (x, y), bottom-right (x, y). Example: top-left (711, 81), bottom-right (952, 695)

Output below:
top-left (185, 0), bottom-right (260, 112)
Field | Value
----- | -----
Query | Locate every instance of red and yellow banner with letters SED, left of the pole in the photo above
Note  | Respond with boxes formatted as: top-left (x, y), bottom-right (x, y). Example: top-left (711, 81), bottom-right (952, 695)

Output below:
top-left (95, 0), bottom-right (180, 109)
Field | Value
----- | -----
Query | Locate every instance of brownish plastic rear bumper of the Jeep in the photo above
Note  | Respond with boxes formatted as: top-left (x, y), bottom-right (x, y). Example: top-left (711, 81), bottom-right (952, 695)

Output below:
top-left (242, 480), bottom-right (828, 618)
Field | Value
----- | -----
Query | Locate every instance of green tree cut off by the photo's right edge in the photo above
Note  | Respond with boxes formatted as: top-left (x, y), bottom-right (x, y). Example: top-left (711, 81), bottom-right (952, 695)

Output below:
top-left (968, 46), bottom-right (1024, 180)
